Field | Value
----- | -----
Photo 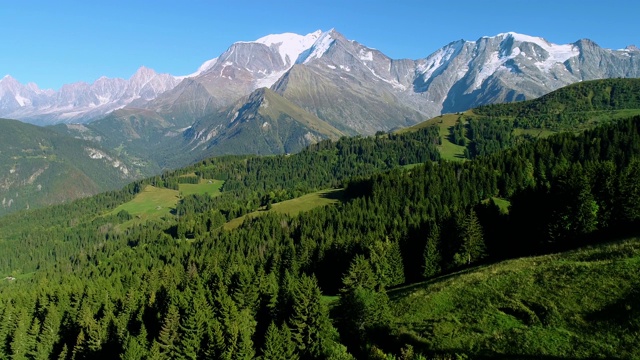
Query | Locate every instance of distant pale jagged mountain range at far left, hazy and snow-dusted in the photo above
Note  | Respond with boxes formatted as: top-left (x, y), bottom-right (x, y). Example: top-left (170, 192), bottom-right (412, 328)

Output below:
top-left (0, 66), bottom-right (180, 124)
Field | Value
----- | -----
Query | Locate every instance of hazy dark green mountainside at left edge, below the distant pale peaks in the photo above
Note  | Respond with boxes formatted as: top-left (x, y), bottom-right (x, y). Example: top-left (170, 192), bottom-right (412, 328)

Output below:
top-left (0, 119), bottom-right (141, 215)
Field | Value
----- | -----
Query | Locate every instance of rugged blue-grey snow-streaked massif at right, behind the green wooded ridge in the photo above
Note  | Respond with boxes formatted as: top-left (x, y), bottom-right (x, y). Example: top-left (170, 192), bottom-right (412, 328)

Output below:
top-left (432, 33), bottom-right (640, 113)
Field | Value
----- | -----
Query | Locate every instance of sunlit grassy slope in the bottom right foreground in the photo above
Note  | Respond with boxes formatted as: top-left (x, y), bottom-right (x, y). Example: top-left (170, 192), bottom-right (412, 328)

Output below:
top-left (390, 239), bottom-right (640, 358)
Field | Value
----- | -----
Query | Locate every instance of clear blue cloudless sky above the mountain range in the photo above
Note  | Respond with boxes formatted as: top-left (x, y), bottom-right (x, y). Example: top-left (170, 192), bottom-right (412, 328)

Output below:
top-left (0, 0), bottom-right (640, 89)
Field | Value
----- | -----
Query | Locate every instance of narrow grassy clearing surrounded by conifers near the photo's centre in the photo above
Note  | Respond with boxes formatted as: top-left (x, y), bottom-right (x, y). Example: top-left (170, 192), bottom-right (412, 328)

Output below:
top-left (224, 189), bottom-right (342, 230)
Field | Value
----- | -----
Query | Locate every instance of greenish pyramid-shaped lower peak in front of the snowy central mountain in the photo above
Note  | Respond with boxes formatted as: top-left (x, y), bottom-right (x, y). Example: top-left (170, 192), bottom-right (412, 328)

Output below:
top-left (184, 88), bottom-right (344, 156)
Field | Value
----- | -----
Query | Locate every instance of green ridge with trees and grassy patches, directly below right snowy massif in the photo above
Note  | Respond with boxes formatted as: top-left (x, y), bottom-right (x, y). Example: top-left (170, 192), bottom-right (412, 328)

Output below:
top-left (398, 79), bottom-right (640, 160)
